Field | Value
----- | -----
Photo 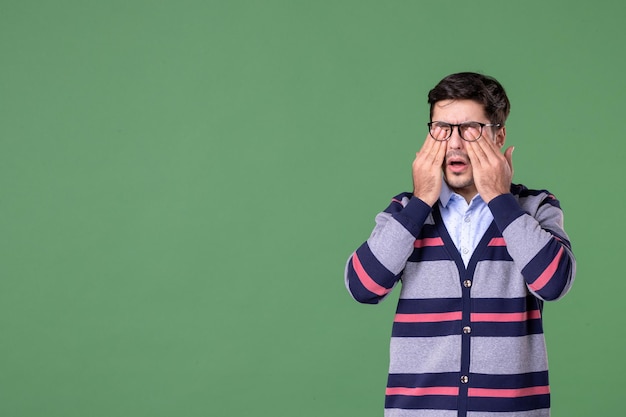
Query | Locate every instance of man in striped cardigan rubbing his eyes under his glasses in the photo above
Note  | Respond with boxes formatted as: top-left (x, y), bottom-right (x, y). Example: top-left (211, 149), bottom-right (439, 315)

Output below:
top-left (346, 73), bottom-right (575, 417)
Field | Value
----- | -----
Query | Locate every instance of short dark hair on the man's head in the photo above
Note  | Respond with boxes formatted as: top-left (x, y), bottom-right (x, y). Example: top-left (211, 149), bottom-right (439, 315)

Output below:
top-left (428, 72), bottom-right (511, 126)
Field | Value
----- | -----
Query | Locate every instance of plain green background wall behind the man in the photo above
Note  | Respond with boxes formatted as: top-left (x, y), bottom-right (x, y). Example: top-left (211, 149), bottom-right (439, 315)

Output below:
top-left (0, 0), bottom-right (626, 417)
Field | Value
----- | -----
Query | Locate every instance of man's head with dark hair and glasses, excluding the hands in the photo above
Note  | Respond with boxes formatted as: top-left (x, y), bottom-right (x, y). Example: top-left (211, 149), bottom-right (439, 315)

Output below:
top-left (428, 72), bottom-right (510, 201)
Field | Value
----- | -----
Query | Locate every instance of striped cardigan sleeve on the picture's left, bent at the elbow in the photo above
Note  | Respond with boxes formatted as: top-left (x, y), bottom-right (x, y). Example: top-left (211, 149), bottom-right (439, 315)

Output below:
top-left (345, 193), bottom-right (432, 304)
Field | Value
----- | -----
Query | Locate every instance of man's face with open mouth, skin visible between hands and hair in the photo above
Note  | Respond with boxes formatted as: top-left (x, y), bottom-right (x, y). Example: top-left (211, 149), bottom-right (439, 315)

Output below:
top-left (432, 100), bottom-right (505, 198)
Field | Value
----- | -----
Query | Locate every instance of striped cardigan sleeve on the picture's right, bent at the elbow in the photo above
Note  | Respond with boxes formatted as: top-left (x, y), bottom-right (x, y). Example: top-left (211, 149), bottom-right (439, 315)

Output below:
top-left (489, 192), bottom-right (576, 301)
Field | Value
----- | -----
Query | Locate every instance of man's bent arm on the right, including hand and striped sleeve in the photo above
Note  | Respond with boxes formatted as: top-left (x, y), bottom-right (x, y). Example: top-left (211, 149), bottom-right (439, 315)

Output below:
top-left (467, 130), bottom-right (576, 300)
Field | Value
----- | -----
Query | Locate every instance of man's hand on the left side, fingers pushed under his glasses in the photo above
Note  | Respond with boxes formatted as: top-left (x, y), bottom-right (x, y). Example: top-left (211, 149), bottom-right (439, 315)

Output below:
top-left (413, 129), bottom-right (447, 207)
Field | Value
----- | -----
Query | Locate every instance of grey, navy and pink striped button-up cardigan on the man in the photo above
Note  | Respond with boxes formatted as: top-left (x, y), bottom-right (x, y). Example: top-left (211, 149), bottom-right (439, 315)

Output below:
top-left (346, 185), bottom-right (576, 417)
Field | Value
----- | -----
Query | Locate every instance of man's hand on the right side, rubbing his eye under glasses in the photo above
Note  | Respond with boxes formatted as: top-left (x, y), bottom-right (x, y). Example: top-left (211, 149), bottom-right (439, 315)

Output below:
top-left (465, 129), bottom-right (515, 203)
